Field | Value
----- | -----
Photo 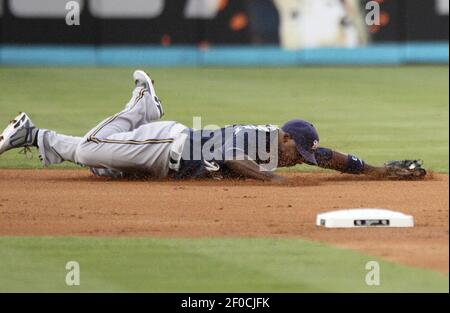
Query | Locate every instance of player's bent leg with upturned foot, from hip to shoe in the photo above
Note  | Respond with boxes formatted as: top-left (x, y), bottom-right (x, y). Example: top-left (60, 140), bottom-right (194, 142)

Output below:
top-left (75, 71), bottom-right (178, 176)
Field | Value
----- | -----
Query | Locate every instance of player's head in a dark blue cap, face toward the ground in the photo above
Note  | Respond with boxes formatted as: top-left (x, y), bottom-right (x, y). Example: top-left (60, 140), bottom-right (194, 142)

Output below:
top-left (278, 119), bottom-right (319, 166)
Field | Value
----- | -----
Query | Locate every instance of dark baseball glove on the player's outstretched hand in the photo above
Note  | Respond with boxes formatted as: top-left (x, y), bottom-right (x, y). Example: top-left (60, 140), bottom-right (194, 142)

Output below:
top-left (384, 160), bottom-right (427, 179)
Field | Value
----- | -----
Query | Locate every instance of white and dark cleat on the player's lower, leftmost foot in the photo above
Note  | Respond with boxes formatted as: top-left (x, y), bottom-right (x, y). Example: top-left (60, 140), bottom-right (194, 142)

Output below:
top-left (0, 113), bottom-right (38, 154)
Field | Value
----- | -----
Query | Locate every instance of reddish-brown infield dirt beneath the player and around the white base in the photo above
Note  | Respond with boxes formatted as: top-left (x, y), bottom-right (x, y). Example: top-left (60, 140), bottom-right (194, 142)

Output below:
top-left (0, 169), bottom-right (449, 273)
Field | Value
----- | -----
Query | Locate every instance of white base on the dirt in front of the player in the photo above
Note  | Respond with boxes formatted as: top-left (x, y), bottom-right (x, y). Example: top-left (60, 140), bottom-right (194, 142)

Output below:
top-left (316, 208), bottom-right (414, 228)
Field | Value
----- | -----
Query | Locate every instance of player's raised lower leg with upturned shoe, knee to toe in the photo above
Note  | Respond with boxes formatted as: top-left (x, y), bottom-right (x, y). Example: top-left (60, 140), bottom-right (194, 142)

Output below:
top-left (85, 70), bottom-right (164, 139)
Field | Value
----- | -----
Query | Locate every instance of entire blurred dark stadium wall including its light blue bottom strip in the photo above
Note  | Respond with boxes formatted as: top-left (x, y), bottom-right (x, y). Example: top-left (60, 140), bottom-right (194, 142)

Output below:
top-left (0, 0), bottom-right (449, 66)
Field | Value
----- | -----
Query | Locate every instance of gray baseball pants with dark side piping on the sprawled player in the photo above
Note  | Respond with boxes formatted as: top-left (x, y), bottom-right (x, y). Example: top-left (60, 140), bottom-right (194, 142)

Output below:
top-left (38, 87), bottom-right (181, 177)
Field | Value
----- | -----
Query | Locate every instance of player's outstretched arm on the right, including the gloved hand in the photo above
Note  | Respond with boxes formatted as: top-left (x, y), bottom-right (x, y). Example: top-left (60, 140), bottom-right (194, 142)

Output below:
top-left (308, 147), bottom-right (426, 179)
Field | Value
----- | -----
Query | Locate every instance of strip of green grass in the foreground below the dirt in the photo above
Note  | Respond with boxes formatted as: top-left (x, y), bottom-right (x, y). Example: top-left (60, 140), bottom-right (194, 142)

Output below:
top-left (0, 237), bottom-right (448, 292)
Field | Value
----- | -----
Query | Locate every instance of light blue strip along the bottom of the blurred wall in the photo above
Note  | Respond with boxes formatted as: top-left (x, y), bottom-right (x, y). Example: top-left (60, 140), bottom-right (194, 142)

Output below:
top-left (0, 42), bottom-right (449, 67)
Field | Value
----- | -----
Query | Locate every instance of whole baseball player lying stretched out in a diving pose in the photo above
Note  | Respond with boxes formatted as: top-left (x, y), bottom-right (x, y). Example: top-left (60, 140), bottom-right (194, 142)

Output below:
top-left (0, 70), bottom-right (426, 181)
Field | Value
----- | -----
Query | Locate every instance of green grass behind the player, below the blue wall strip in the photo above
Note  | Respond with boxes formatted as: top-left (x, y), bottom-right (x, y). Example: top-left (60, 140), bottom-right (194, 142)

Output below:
top-left (0, 66), bottom-right (449, 172)
